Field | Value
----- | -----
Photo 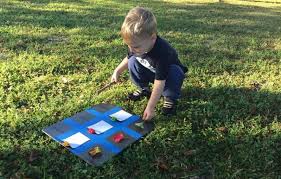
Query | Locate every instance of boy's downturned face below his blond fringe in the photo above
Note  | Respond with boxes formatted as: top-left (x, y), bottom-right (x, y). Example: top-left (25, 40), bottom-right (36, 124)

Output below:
top-left (124, 34), bottom-right (157, 56)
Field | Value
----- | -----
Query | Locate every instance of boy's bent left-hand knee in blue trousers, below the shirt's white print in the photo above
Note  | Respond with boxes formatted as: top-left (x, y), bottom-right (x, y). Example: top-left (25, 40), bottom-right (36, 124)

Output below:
top-left (128, 56), bottom-right (155, 89)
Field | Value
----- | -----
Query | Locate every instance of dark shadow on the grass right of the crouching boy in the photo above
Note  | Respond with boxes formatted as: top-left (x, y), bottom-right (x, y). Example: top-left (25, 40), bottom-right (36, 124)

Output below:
top-left (179, 87), bottom-right (281, 132)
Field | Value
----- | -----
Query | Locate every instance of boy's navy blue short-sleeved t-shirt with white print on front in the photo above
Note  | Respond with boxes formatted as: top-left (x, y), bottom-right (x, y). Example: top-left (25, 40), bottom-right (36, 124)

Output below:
top-left (127, 36), bottom-right (187, 80)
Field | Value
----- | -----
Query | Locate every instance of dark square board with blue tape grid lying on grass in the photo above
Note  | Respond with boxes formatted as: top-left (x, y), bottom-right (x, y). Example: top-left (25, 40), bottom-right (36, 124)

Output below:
top-left (43, 104), bottom-right (154, 166)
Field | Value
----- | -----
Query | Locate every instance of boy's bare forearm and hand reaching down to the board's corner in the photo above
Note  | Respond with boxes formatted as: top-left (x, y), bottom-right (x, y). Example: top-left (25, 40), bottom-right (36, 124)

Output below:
top-left (142, 80), bottom-right (166, 120)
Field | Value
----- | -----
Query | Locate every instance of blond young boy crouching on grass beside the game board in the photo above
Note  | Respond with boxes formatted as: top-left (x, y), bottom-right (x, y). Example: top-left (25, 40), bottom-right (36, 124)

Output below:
top-left (111, 7), bottom-right (187, 120)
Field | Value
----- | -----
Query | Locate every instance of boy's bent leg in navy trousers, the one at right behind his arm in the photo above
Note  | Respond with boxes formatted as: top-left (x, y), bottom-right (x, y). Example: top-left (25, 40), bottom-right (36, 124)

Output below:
top-left (163, 65), bottom-right (185, 101)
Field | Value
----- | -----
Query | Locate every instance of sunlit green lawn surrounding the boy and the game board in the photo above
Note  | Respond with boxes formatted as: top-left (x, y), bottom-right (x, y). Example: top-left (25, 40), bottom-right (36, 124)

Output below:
top-left (0, 0), bottom-right (281, 178)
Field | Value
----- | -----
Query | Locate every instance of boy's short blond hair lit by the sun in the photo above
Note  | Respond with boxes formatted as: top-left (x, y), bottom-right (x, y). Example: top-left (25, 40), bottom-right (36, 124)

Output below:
top-left (121, 7), bottom-right (157, 40)
